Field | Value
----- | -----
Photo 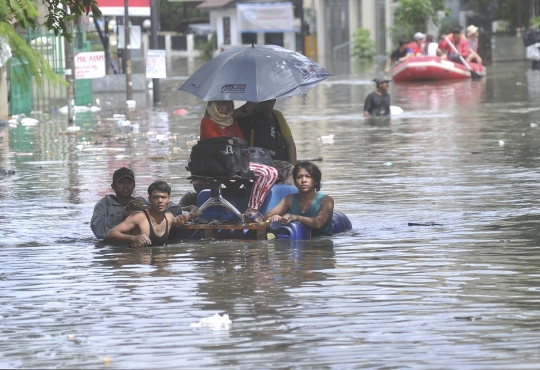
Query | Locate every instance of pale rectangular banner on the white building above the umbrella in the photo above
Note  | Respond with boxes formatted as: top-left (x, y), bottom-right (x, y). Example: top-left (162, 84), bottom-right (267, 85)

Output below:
top-left (236, 3), bottom-right (295, 32)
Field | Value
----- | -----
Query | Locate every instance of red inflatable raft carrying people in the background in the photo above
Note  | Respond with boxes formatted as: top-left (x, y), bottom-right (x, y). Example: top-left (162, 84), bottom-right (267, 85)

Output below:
top-left (392, 56), bottom-right (486, 81)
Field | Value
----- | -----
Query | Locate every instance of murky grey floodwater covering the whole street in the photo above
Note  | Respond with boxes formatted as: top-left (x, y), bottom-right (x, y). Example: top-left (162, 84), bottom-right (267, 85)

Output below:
top-left (0, 55), bottom-right (540, 369)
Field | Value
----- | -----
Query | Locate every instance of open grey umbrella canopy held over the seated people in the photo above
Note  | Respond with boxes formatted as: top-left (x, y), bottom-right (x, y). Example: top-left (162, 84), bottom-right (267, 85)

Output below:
top-left (179, 45), bottom-right (332, 102)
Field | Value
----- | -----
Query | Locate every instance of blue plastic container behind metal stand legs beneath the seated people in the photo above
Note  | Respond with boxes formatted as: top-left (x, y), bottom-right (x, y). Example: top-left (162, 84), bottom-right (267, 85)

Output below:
top-left (197, 184), bottom-right (298, 221)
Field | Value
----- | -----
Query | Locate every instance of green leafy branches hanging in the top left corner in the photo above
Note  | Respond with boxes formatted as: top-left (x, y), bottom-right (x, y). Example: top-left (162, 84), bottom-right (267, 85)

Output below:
top-left (0, 0), bottom-right (101, 83)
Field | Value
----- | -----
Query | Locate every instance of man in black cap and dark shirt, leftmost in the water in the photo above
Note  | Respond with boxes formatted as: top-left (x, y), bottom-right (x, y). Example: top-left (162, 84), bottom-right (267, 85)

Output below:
top-left (90, 167), bottom-right (135, 239)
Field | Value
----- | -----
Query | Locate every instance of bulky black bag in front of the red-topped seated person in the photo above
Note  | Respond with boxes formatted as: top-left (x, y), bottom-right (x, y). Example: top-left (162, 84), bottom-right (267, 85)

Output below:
top-left (186, 136), bottom-right (253, 178)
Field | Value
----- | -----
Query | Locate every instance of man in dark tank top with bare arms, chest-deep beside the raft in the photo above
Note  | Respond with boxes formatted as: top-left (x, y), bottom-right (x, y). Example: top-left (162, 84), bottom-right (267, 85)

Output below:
top-left (106, 181), bottom-right (202, 247)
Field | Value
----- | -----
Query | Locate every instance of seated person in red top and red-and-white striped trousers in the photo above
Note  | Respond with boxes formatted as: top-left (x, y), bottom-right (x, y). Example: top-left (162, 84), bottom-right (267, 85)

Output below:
top-left (201, 100), bottom-right (278, 222)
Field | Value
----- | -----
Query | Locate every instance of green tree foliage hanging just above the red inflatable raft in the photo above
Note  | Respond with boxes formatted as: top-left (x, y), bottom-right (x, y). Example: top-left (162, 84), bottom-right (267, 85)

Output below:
top-left (390, 0), bottom-right (445, 44)
